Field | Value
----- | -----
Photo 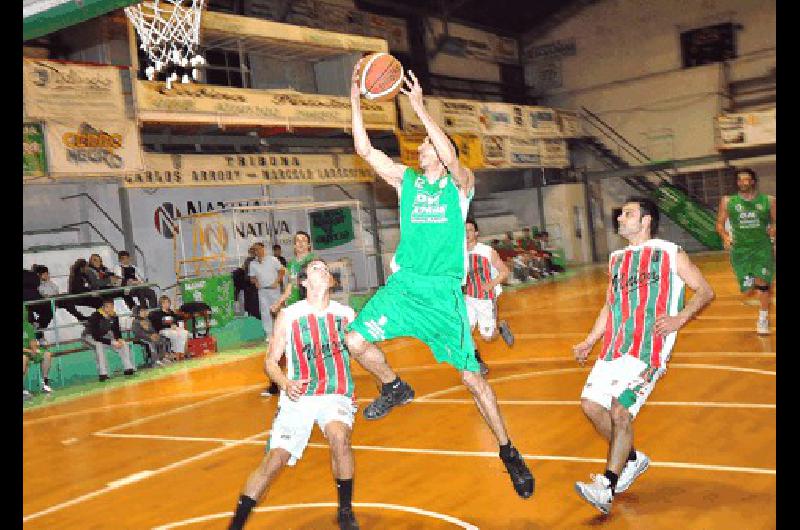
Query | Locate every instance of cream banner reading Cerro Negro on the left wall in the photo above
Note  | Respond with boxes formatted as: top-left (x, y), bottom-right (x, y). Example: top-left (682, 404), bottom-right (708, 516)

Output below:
top-left (46, 116), bottom-right (144, 177)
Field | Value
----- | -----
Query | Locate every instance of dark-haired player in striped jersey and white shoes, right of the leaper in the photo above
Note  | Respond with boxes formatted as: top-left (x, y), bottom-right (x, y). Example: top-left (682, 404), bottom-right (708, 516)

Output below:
top-left (573, 197), bottom-right (714, 513)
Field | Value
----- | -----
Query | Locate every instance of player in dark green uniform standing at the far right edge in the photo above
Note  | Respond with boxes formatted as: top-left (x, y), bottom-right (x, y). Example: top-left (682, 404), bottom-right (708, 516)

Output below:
top-left (717, 168), bottom-right (776, 335)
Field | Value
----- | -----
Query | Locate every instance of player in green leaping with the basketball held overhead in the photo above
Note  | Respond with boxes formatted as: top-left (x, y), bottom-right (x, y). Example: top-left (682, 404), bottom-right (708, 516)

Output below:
top-left (347, 59), bottom-right (534, 498)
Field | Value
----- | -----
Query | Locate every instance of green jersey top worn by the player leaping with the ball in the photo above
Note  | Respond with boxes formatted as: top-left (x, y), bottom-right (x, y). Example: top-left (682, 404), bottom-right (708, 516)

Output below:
top-left (392, 168), bottom-right (473, 281)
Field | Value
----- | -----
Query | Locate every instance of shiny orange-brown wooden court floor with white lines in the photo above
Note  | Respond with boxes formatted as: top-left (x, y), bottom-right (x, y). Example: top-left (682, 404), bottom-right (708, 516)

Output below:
top-left (23, 253), bottom-right (776, 530)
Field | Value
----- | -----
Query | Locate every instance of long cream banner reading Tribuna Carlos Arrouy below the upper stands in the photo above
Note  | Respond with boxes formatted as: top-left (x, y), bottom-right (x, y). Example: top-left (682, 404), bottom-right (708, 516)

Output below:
top-left (125, 153), bottom-right (375, 188)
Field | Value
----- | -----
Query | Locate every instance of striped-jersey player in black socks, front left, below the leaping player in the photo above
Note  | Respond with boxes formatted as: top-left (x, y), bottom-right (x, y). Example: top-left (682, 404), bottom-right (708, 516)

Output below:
top-left (228, 259), bottom-right (359, 530)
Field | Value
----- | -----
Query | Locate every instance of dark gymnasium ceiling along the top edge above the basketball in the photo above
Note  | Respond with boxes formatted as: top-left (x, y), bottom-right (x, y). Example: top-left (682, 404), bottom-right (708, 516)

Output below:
top-left (355, 0), bottom-right (593, 37)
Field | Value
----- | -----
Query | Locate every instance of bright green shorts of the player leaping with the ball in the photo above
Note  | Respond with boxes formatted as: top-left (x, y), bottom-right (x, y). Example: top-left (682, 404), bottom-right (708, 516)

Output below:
top-left (348, 270), bottom-right (480, 372)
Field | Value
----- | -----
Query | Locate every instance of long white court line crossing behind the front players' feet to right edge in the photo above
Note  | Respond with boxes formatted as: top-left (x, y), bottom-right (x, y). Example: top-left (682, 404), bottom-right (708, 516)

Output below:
top-left (92, 433), bottom-right (776, 475)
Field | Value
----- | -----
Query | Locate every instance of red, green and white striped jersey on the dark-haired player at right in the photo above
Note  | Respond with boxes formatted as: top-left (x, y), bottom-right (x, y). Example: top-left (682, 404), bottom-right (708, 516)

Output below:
top-left (600, 239), bottom-right (685, 368)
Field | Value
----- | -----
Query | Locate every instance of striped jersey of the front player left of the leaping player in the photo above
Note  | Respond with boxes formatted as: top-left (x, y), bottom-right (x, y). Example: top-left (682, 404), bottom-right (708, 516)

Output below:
top-left (283, 300), bottom-right (355, 397)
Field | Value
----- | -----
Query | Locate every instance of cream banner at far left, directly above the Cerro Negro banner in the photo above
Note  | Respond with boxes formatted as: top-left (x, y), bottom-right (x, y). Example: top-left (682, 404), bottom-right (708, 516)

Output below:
top-left (22, 58), bottom-right (125, 121)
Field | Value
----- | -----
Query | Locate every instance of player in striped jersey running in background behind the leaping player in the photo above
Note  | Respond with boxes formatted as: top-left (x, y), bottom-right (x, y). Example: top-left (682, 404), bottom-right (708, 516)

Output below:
top-left (464, 217), bottom-right (514, 375)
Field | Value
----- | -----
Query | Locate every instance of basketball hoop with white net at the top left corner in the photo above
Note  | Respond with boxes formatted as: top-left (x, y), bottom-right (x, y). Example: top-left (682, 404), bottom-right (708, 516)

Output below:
top-left (125, 0), bottom-right (206, 90)
